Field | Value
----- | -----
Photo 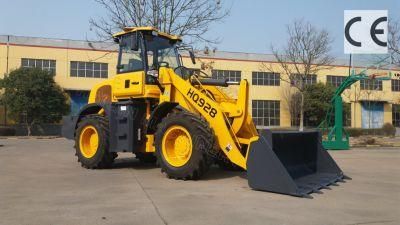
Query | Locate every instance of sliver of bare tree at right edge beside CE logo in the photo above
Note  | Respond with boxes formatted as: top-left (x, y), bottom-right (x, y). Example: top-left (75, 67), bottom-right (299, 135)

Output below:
top-left (388, 21), bottom-right (400, 66)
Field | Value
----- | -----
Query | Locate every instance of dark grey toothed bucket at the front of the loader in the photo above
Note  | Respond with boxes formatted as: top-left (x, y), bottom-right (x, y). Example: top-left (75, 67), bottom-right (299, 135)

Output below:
top-left (247, 130), bottom-right (347, 197)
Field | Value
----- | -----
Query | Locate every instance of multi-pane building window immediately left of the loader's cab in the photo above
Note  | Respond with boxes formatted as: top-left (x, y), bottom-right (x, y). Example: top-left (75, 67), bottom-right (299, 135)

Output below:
top-left (70, 61), bottom-right (108, 78)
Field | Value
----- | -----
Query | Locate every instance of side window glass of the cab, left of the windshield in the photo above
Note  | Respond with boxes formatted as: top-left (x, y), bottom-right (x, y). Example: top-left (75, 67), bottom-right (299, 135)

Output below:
top-left (118, 34), bottom-right (144, 73)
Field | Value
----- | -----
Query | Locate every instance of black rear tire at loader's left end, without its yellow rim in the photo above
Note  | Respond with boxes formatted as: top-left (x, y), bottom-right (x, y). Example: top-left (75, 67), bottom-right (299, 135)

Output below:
top-left (75, 115), bottom-right (117, 169)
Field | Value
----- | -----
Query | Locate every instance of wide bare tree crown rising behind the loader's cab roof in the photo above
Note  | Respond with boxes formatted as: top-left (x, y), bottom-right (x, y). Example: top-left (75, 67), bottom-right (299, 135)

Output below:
top-left (90, 0), bottom-right (229, 42)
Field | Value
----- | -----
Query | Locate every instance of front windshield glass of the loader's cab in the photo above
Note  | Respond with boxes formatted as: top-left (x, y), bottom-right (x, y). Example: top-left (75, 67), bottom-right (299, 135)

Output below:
top-left (144, 35), bottom-right (180, 70)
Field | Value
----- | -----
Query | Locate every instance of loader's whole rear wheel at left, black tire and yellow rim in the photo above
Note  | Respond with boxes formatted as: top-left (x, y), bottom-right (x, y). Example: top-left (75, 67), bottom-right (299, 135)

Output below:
top-left (75, 115), bottom-right (117, 169)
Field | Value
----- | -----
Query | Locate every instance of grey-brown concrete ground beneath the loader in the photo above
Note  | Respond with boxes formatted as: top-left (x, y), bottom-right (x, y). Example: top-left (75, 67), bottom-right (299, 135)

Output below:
top-left (0, 139), bottom-right (400, 225)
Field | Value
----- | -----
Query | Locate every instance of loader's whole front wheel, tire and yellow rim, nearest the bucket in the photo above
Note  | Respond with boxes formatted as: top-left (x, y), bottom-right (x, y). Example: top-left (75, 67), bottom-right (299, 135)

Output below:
top-left (155, 111), bottom-right (215, 180)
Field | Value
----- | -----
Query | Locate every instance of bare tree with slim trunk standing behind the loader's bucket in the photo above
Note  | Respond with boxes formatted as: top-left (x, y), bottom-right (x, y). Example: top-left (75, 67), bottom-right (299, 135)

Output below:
top-left (264, 20), bottom-right (334, 131)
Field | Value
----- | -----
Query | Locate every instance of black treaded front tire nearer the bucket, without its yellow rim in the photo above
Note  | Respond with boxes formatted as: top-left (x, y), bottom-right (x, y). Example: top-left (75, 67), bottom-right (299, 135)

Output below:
top-left (155, 111), bottom-right (215, 180)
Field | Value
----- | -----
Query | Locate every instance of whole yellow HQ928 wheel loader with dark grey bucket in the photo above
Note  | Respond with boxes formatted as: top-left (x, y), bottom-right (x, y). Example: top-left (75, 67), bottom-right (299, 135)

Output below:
top-left (62, 27), bottom-right (346, 197)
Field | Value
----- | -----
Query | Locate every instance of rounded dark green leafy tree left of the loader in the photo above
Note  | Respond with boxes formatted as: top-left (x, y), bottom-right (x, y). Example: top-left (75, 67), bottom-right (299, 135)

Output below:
top-left (0, 68), bottom-right (69, 136)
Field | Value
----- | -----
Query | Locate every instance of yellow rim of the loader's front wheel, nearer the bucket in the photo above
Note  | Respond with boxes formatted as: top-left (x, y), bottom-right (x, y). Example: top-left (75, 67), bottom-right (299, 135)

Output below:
top-left (162, 125), bottom-right (192, 167)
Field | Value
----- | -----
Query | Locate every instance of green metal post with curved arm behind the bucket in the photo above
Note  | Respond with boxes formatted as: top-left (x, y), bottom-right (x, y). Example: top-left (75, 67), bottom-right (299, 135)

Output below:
top-left (318, 69), bottom-right (391, 150)
